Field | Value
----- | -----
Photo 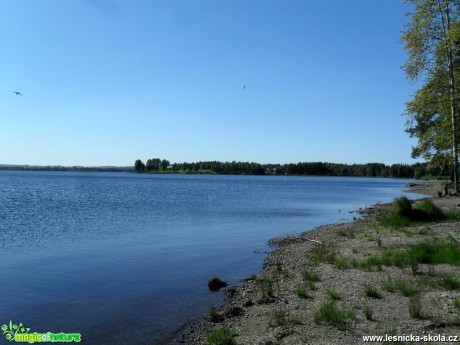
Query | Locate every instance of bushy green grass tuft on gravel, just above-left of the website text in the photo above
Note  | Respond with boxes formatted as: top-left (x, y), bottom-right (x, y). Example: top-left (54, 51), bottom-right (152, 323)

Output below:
top-left (315, 301), bottom-right (356, 329)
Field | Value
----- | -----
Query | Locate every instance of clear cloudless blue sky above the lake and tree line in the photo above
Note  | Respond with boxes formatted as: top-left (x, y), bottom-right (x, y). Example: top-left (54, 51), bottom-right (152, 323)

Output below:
top-left (0, 0), bottom-right (422, 166)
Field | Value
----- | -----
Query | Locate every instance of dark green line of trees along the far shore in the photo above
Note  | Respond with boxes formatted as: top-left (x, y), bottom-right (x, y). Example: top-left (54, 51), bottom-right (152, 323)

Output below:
top-left (134, 158), bottom-right (432, 178)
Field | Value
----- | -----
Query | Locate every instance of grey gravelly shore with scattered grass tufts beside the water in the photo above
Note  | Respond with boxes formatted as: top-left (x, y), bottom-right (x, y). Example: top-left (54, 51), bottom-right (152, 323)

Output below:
top-left (182, 182), bottom-right (460, 345)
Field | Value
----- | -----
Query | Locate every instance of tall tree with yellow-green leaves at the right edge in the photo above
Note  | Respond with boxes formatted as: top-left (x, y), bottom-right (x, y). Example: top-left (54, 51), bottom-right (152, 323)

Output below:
top-left (402, 0), bottom-right (460, 193)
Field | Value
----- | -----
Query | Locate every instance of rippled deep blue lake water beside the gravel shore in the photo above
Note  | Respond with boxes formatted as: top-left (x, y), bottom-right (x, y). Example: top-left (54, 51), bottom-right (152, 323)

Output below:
top-left (0, 171), bottom-right (426, 345)
